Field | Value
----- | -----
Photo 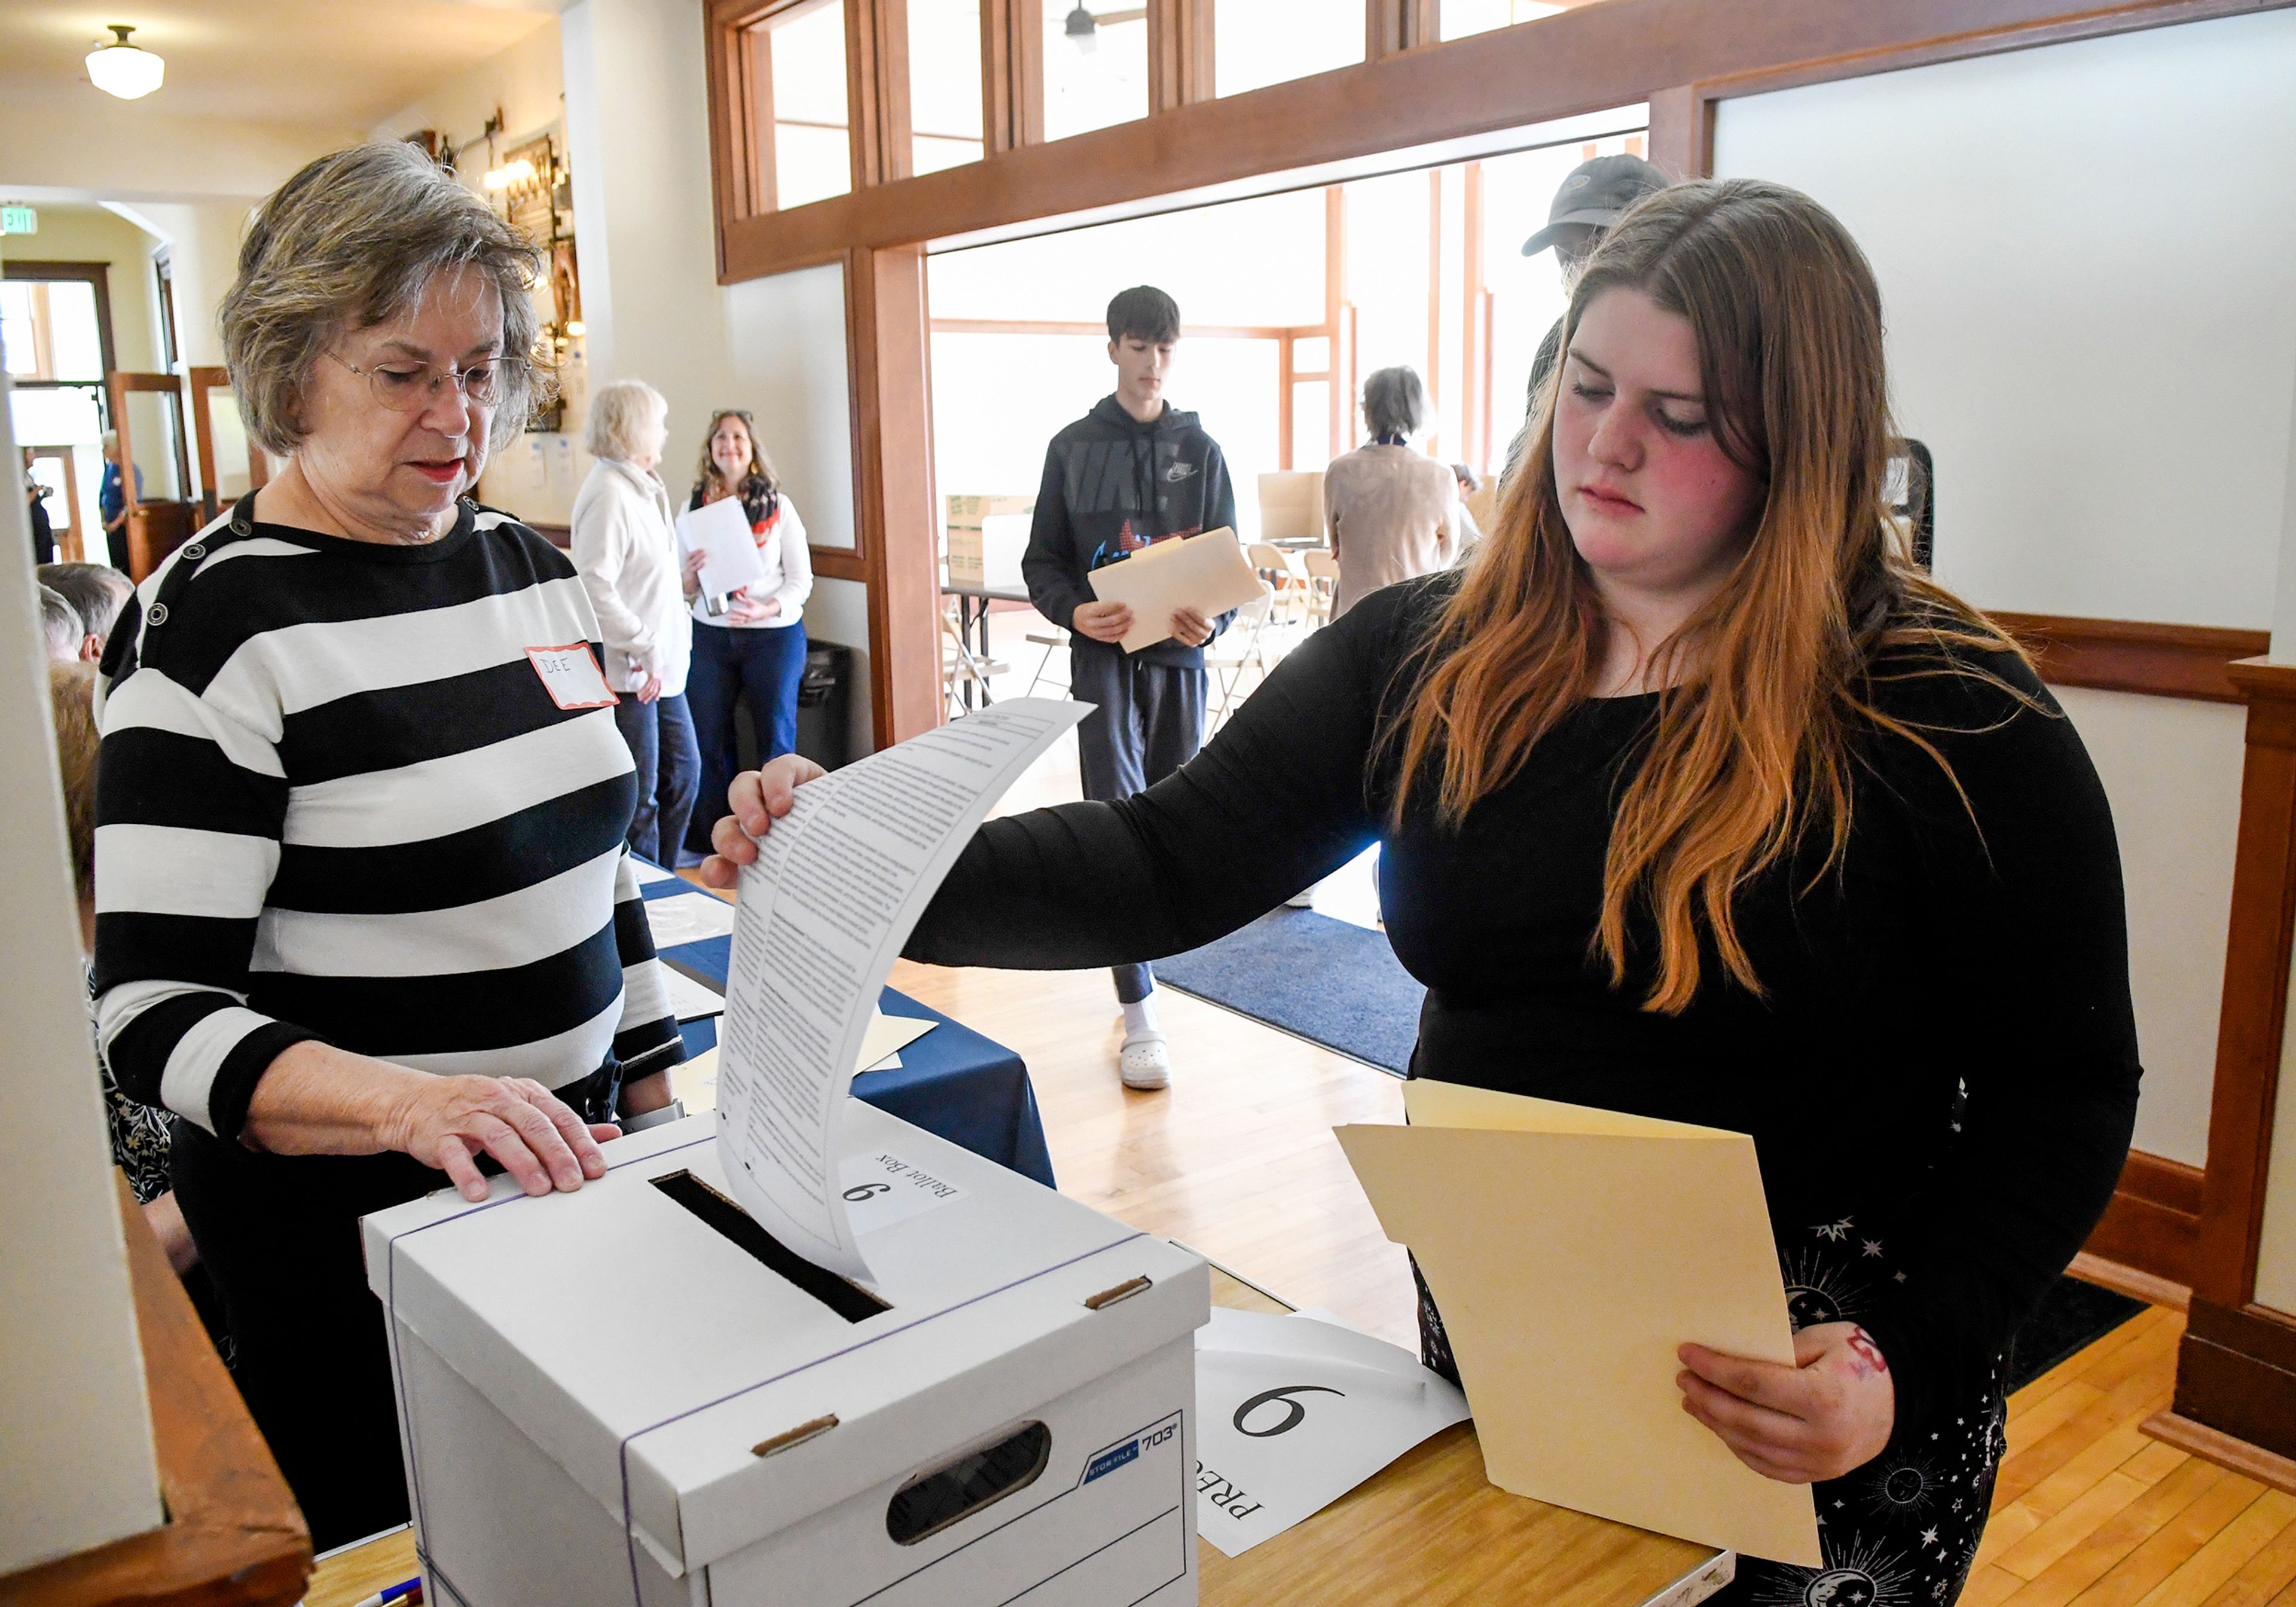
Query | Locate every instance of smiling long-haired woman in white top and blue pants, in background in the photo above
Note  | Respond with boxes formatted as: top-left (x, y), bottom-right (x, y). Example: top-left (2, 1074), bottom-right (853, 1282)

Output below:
top-left (686, 409), bottom-right (813, 852)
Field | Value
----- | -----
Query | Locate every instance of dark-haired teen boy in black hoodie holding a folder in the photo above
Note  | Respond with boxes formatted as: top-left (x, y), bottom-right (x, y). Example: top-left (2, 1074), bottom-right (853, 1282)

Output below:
top-left (1019, 285), bottom-right (1235, 1088)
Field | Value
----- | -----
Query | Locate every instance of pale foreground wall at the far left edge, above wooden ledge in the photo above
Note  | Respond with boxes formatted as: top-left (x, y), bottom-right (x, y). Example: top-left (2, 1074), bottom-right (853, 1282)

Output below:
top-left (0, 381), bottom-right (163, 1575)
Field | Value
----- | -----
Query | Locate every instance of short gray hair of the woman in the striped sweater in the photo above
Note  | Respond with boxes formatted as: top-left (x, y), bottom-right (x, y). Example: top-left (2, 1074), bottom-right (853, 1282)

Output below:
top-left (222, 140), bottom-right (551, 457)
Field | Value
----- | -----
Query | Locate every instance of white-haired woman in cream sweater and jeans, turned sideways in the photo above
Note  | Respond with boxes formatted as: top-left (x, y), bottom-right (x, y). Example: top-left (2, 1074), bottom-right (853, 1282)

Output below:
top-left (574, 379), bottom-right (693, 868)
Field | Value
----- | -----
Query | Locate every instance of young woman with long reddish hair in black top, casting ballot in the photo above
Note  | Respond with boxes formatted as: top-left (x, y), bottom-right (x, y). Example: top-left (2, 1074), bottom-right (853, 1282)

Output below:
top-left (705, 181), bottom-right (2140, 1607)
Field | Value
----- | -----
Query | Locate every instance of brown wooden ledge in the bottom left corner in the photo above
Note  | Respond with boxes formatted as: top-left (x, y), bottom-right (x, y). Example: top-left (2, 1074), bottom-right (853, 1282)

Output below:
top-left (0, 1178), bottom-right (310, 1607)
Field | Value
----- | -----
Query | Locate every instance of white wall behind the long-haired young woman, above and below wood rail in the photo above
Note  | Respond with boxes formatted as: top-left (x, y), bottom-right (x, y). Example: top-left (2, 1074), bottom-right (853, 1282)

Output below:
top-left (1715, 11), bottom-right (2296, 1166)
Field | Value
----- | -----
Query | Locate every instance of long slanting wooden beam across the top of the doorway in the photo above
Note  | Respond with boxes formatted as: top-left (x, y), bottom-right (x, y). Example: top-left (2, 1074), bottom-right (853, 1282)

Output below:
top-left (723, 0), bottom-right (2296, 280)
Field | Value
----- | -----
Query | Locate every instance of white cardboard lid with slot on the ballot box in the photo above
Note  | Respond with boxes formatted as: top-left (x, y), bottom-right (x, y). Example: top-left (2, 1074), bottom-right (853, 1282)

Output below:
top-left (363, 1102), bottom-right (1208, 1572)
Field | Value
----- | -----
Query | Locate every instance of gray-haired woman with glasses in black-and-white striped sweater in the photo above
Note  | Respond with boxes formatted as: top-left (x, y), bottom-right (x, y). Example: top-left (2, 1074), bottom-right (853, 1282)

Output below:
top-left (94, 142), bottom-right (684, 1550)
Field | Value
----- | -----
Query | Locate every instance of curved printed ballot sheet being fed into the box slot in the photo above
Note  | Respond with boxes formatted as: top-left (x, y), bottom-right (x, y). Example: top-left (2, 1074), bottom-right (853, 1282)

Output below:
top-left (716, 698), bottom-right (1093, 1279)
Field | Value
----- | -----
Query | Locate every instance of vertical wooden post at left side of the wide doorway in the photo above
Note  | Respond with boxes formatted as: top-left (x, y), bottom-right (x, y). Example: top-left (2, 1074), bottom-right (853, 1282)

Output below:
top-left (845, 246), bottom-right (941, 748)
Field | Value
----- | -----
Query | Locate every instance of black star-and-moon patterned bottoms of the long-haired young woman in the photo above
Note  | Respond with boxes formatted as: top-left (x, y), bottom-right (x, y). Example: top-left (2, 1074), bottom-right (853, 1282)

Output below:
top-left (1412, 1217), bottom-right (2009, 1607)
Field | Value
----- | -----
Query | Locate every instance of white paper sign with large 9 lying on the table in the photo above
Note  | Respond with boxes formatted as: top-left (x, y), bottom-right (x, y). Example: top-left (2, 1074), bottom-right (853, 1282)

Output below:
top-left (1196, 1306), bottom-right (1467, 1557)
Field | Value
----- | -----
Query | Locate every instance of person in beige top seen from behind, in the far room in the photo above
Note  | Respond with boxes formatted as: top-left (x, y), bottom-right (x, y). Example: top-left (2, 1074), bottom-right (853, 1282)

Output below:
top-left (1323, 367), bottom-right (1458, 620)
